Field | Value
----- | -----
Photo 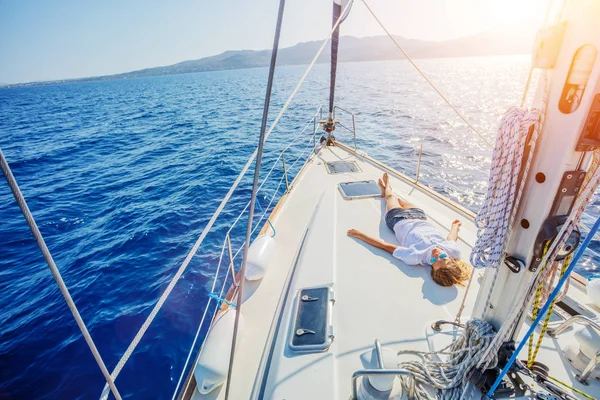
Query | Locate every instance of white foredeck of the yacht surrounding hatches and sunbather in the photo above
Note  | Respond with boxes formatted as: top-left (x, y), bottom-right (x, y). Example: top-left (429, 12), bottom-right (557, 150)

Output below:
top-left (193, 142), bottom-right (600, 400)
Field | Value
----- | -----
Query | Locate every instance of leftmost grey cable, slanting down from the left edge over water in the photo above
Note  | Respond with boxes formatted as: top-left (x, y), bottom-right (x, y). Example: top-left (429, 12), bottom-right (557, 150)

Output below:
top-left (0, 149), bottom-right (121, 400)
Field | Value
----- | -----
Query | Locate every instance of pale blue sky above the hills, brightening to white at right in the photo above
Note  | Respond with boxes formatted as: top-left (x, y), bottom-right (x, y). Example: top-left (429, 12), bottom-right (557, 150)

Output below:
top-left (0, 0), bottom-right (548, 83)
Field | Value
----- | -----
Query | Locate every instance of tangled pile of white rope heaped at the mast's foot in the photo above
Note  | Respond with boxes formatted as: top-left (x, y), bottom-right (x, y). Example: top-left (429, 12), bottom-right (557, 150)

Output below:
top-left (398, 319), bottom-right (497, 400)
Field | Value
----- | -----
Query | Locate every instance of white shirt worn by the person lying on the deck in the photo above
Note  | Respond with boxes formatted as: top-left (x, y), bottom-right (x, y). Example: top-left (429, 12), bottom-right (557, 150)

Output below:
top-left (393, 219), bottom-right (460, 265)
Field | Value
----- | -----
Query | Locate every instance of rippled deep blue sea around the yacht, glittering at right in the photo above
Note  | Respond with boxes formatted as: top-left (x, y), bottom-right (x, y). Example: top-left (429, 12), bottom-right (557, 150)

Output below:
top-left (0, 56), bottom-right (600, 400)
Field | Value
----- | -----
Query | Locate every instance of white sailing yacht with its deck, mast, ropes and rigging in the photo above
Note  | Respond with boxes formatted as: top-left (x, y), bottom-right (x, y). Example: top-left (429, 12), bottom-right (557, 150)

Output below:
top-left (0, 0), bottom-right (600, 400)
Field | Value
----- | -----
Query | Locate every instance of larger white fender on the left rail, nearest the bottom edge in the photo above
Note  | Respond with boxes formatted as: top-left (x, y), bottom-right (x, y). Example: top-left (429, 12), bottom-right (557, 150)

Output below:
top-left (194, 308), bottom-right (244, 394)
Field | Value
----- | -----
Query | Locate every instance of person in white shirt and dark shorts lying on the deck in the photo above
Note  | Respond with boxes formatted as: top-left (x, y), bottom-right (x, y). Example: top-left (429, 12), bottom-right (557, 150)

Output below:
top-left (348, 173), bottom-right (471, 286)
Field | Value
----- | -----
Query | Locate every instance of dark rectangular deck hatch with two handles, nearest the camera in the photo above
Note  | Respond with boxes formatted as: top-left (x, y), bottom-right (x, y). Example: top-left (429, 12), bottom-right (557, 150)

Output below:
top-left (289, 286), bottom-right (334, 352)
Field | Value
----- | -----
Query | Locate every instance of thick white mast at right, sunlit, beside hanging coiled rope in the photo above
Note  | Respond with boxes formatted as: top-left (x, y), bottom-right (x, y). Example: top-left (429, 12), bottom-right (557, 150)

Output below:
top-left (472, 0), bottom-right (600, 339)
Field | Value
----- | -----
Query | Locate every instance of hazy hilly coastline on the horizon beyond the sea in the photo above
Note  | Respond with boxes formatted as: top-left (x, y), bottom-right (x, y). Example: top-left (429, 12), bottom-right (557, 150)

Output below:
top-left (0, 29), bottom-right (533, 87)
